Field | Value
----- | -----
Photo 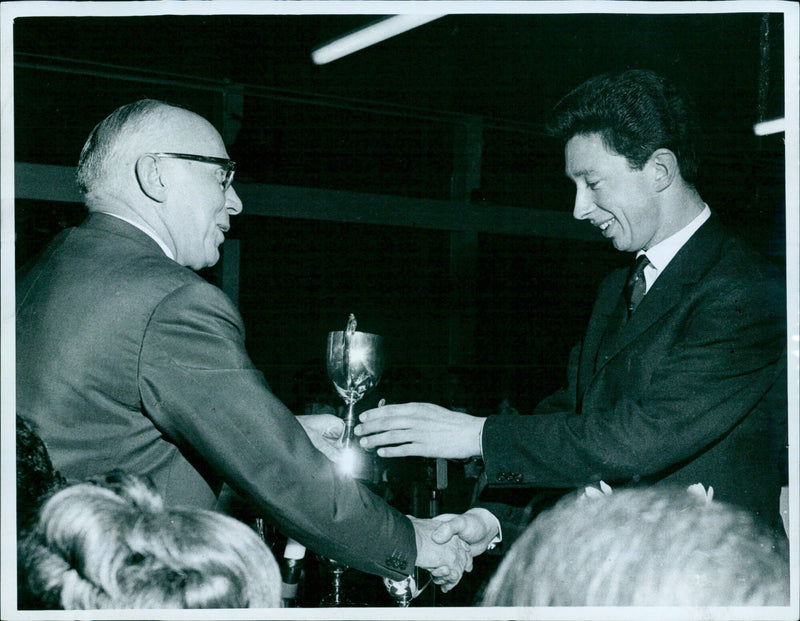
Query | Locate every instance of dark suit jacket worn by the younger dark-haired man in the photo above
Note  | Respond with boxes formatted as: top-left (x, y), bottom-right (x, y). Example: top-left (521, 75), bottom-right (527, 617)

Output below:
top-left (483, 215), bottom-right (788, 538)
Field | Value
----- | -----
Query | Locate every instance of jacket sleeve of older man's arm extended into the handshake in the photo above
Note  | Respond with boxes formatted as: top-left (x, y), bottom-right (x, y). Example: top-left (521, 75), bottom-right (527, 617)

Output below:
top-left (139, 282), bottom-right (416, 579)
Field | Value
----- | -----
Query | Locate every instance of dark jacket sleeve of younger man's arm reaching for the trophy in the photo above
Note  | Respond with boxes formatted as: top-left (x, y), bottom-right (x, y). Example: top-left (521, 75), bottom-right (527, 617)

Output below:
top-left (483, 260), bottom-right (786, 487)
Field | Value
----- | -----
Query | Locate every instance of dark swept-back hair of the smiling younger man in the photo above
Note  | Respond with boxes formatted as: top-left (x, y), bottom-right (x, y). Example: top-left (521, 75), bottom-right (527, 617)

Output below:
top-left (547, 69), bottom-right (700, 185)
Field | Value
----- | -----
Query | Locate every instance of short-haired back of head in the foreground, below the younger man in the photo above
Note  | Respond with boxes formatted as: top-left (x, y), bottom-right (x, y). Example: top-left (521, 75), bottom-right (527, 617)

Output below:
top-left (482, 487), bottom-right (789, 607)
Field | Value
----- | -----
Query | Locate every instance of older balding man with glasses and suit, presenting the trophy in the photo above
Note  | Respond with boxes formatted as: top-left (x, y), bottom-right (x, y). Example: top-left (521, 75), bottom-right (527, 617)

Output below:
top-left (17, 100), bottom-right (471, 590)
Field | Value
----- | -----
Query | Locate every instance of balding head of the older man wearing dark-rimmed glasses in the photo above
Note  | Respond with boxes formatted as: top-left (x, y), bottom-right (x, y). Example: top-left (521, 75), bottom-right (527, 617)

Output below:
top-left (77, 99), bottom-right (242, 269)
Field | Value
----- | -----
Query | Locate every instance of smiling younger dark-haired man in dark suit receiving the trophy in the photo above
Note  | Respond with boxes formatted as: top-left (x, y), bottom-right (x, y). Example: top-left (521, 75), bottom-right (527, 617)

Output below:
top-left (356, 70), bottom-right (787, 553)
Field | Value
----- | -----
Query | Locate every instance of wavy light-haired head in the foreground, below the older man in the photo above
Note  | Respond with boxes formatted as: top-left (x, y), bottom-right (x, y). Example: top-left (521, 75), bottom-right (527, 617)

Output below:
top-left (20, 474), bottom-right (280, 610)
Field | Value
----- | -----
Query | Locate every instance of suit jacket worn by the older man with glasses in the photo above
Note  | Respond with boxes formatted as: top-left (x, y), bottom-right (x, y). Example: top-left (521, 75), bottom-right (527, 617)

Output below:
top-left (16, 214), bottom-right (416, 579)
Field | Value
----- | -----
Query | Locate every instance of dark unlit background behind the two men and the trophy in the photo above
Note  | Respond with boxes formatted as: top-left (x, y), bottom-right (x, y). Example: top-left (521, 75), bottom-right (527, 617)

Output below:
top-left (13, 3), bottom-right (786, 605)
